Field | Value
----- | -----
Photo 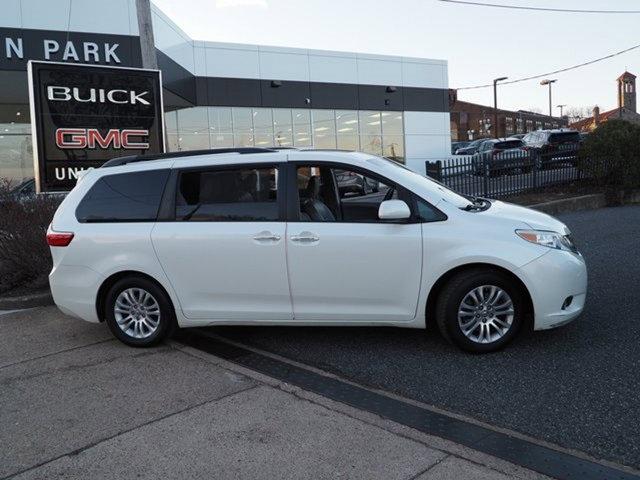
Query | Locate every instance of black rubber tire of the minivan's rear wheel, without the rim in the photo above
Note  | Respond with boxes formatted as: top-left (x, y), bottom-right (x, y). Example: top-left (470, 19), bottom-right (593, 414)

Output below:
top-left (104, 275), bottom-right (177, 347)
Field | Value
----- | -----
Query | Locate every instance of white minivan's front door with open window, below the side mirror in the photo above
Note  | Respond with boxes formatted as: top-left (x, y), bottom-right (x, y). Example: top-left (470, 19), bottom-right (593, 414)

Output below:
top-left (287, 164), bottom-right (422, 322)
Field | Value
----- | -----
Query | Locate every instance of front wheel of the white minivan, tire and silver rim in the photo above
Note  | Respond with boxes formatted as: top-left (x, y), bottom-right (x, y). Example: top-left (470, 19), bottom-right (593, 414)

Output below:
top-left (436, 270), bottom-right (524, 353)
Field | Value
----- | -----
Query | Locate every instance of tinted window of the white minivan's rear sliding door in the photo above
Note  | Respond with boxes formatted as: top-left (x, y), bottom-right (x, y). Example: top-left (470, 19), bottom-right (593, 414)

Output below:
top-left (176, 167), bottom-right (279, 222)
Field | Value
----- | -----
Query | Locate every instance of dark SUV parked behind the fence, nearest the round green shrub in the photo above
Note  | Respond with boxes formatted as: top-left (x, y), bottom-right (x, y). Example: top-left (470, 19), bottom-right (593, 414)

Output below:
top-left (522, 129), bottom-right (582, 167)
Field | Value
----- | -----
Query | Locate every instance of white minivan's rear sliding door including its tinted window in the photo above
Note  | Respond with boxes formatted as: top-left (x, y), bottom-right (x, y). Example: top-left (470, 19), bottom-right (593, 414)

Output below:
top-left (152, 166), bottom-right (293, 320)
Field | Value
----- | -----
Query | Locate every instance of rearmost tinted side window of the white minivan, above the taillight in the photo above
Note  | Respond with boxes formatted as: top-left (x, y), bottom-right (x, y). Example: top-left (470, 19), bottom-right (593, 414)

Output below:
top-left (76, 170), bottom-right (169, 223)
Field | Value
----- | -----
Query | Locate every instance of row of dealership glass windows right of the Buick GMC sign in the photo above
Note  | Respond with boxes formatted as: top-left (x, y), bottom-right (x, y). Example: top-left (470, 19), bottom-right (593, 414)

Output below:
top-left (165, 107), bottom-right (404, 162)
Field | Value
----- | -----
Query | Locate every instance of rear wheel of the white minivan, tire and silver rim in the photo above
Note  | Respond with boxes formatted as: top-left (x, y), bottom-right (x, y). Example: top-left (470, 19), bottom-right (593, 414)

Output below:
top-left (104, 276), bottom-right (176, 347)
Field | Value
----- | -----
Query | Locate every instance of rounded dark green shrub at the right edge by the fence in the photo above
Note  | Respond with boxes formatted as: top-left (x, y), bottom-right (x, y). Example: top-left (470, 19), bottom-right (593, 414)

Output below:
top-left (580, 120), bottom-right (640, 192)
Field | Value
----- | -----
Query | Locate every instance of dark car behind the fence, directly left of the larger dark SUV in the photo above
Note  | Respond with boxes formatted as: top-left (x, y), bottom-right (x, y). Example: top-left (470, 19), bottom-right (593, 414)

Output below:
top-left (472, 138), bottom-right (533, 175)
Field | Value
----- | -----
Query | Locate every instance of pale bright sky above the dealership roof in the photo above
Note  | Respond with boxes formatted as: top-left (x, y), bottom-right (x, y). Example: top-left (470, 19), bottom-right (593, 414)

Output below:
top-left (152, 0), bottom-right (640, 115)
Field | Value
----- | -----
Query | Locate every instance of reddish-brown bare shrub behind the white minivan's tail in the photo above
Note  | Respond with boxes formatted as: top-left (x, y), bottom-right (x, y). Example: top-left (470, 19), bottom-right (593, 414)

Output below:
top-left (0, 180), bottom-right (61, 293)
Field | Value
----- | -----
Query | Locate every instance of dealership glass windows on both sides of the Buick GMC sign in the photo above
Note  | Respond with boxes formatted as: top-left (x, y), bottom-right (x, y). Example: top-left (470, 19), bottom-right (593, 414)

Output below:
top-left (0, 104), bottom-right (404, 185)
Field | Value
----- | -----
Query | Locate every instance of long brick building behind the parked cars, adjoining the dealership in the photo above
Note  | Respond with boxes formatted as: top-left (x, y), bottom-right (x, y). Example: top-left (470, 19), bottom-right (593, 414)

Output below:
top-left (449, 90), bottom-right (568, 141)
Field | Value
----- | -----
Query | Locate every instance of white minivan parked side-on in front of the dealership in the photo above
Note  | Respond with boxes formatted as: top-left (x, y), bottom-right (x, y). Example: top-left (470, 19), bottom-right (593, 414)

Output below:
top-left (47, 148), bottom-right (587, 352)
